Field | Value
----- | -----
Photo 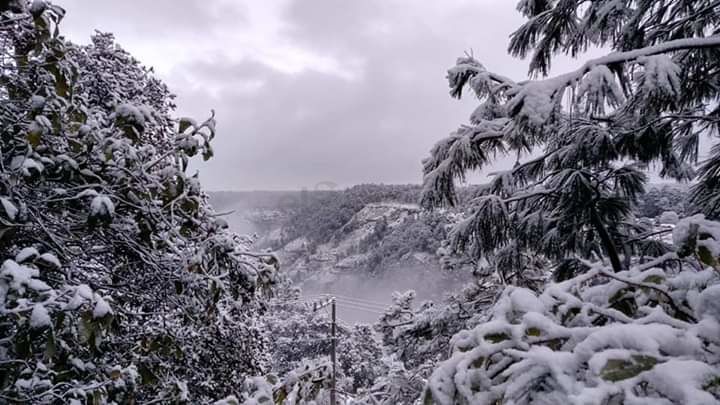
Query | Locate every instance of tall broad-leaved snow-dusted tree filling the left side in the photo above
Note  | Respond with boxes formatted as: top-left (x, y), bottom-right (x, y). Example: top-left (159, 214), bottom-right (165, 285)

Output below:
top-left (0, 0), bottom-right (276, 403)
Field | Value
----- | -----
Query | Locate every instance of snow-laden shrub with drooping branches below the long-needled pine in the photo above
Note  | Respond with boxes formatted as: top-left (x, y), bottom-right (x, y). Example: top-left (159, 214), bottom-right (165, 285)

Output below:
top-left (424, 216), bottom-right (720, 405)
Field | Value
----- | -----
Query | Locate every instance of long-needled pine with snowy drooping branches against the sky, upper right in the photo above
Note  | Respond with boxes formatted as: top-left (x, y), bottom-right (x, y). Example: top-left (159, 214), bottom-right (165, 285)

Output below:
top-left (423, 0), bottom-right (720, 271)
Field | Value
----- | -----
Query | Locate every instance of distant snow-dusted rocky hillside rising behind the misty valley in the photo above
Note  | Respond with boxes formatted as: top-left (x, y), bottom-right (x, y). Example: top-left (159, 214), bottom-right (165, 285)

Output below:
top-left (208, 190), bottom-right (467, 301)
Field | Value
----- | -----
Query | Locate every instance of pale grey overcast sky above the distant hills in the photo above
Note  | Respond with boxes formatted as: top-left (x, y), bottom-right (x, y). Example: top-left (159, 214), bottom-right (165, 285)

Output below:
top-left (55, 0), bottom-right (577, 190)
